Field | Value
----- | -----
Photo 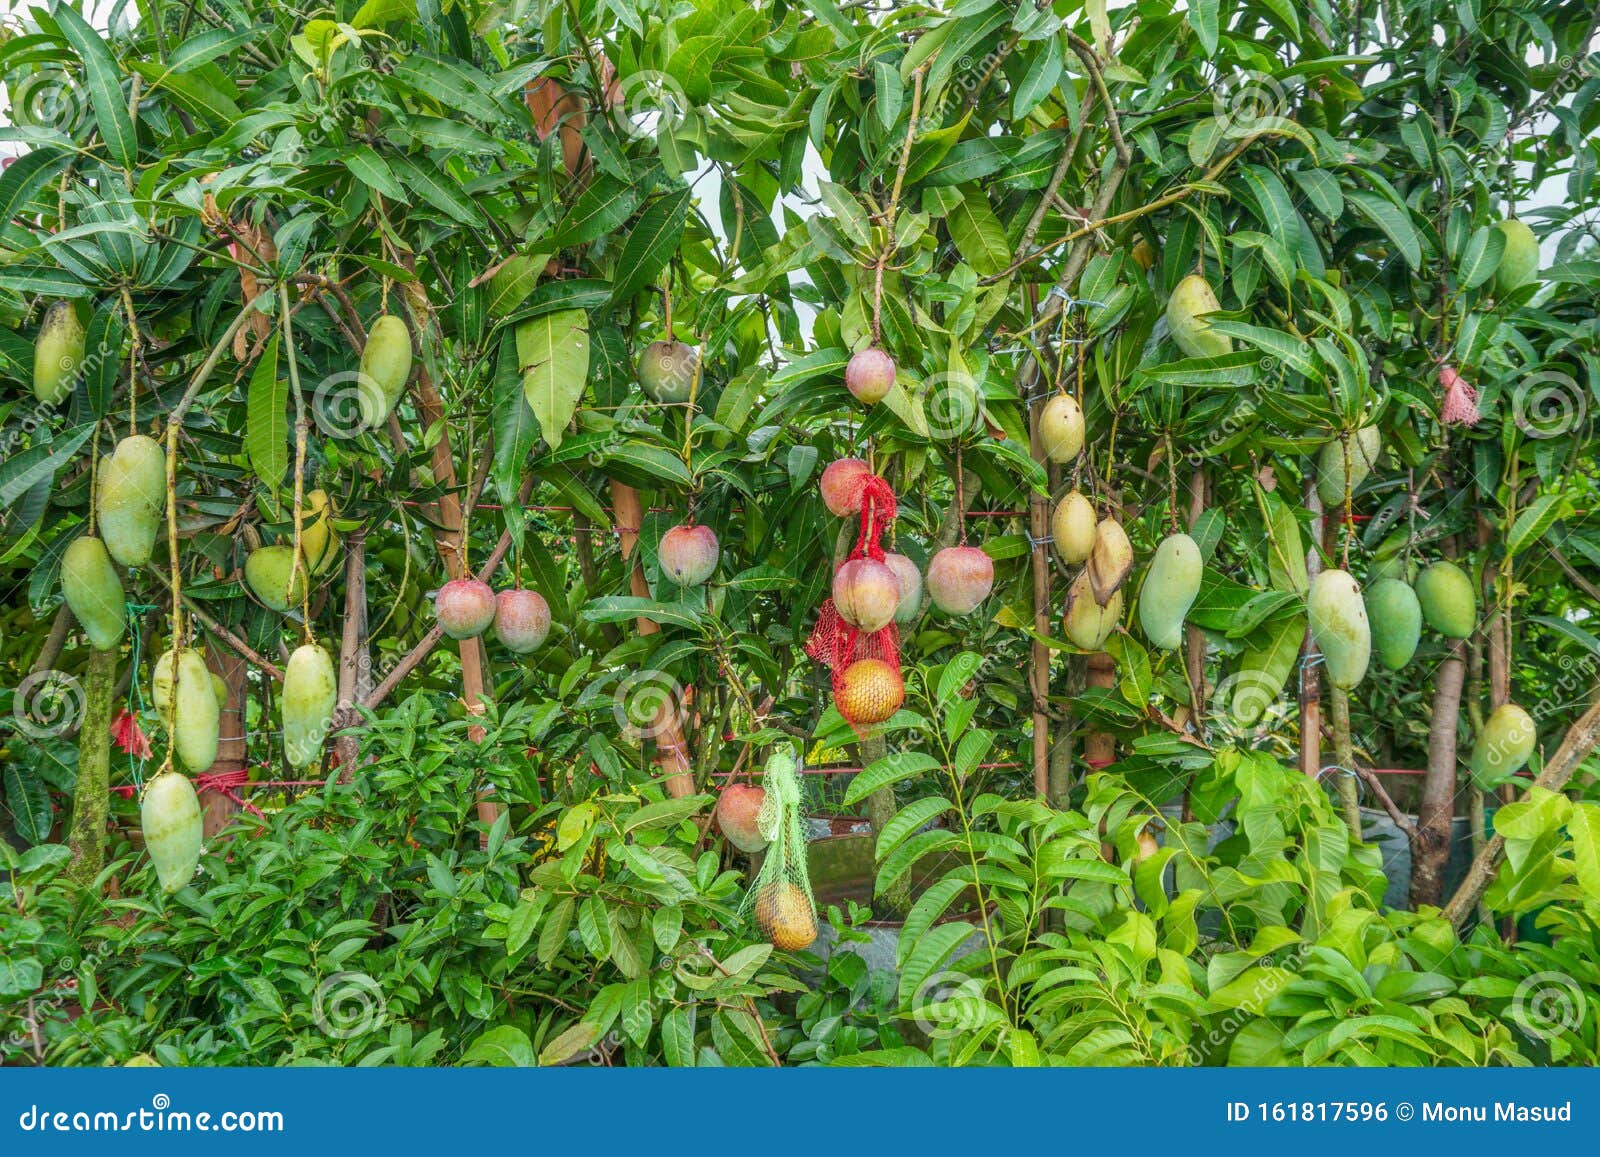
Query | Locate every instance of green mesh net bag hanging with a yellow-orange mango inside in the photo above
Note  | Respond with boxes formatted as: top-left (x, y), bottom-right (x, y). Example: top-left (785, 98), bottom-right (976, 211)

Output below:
top-left (744, 747), bottom-right (816, 952)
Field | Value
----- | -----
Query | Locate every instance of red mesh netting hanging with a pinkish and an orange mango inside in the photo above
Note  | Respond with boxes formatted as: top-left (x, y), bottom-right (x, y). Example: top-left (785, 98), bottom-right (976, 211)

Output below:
top-left (805, 474), bottom-right (906, 738)
